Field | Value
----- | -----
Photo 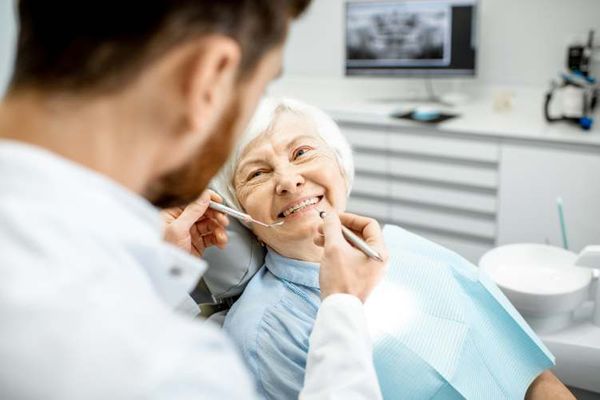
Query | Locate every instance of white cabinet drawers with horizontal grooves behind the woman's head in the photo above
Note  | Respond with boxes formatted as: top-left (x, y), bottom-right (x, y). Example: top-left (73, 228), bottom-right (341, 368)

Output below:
top-left (340, 122), bottom-right (500, 262)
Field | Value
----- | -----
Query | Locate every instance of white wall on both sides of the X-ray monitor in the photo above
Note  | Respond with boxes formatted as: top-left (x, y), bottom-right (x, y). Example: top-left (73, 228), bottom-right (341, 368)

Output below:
top-left (285, 0), bottom-right (600, 86)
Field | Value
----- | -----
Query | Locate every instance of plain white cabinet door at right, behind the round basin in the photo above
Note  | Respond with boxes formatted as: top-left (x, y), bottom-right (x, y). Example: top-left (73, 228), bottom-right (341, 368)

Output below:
top-left (497, 144), bottom-right (600, 252)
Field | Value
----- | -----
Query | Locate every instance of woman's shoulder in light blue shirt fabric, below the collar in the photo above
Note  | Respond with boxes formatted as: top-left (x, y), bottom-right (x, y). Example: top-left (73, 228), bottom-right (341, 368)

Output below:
top-left (224, 267), bottom-right (316, 398)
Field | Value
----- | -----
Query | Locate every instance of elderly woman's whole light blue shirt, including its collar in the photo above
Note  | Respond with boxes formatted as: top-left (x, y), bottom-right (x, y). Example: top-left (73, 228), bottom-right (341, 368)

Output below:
top-left (224, 249), bottom-right (321, 400)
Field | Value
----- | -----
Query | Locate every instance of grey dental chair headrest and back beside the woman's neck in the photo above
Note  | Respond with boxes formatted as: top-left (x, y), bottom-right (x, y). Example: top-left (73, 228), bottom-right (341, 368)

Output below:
top-left (190, 218), bottom-right (266, 326)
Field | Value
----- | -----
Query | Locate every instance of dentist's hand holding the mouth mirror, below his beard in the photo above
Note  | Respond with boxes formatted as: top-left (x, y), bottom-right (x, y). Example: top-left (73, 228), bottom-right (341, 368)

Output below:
top-left (161, 190), bottom-right (229, 257)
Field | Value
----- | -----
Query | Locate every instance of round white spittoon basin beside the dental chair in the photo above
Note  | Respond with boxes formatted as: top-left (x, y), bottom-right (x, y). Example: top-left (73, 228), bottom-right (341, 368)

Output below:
top-left (479, 244), bottom-right (592, 332)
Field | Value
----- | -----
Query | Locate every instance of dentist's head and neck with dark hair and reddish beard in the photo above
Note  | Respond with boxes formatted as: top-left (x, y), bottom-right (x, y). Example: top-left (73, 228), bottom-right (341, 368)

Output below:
top-left (0, 0), bottom-right (309, 206)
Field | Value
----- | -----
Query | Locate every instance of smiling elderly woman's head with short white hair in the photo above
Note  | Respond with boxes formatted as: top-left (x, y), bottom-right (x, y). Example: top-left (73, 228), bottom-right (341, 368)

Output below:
top-left (212, 99), bottom-right (354, 261)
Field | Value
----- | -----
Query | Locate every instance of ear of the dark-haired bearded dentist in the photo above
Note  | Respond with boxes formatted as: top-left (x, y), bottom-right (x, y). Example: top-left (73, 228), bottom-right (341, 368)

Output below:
top-left (182, 35), bottom-right (242, 140)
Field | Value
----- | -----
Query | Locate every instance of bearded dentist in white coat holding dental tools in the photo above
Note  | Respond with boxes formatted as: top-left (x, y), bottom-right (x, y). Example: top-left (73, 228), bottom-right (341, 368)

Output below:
top-left (0, 0), bottom-right (384, 399)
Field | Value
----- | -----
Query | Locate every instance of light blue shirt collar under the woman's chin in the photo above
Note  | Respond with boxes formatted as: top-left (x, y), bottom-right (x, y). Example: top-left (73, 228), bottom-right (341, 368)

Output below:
top-left (265, 248), bottom-right (319, 289)
